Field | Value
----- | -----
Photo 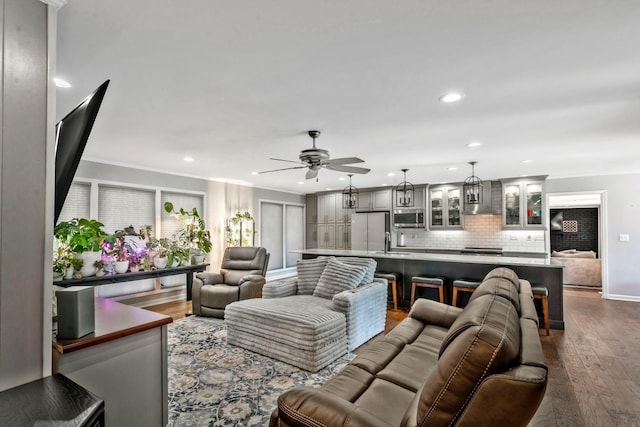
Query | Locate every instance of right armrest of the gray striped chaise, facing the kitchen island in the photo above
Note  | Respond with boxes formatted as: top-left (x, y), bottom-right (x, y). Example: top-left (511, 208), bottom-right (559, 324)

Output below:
top-left (332, 280), bottom-right (387, 351)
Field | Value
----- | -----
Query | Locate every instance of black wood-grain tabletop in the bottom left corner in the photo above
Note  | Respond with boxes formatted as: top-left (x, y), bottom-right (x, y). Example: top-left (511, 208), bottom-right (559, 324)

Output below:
top-left (0, 374), bottom-right (105, 427)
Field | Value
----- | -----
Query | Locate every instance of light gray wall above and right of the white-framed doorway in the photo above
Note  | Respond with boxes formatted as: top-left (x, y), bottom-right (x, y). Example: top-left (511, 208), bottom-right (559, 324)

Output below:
top-left (546, 174), bottom-right (640, 301)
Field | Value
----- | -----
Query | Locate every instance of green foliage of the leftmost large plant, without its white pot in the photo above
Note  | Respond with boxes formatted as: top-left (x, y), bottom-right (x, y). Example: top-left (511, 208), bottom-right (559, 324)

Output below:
top-left (53, 218), bottom-right (107, 254)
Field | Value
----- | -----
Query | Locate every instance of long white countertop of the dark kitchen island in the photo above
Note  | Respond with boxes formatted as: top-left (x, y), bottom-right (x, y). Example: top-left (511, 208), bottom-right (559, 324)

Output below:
top-left (291, 249), bottom-right (564, 268)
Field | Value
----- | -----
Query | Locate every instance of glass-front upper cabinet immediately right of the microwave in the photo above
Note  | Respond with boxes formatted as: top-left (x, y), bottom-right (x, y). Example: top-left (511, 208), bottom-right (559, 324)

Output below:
top-left (428, 184), bottom-right (462, 230)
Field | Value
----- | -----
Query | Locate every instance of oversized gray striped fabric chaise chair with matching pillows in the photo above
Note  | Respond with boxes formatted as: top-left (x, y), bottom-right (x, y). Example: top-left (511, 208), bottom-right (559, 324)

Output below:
top-left (225, 257), bottom-right (387, 371)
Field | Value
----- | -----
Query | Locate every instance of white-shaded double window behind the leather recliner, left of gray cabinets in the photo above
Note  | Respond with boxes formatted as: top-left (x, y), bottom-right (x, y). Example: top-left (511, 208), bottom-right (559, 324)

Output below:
top-left (260, 202), bottom-right (305, 271)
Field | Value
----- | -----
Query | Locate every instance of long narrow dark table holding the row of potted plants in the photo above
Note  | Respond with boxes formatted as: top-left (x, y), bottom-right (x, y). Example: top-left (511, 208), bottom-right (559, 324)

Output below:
top-left (53, 263), bottom-right (209, 301)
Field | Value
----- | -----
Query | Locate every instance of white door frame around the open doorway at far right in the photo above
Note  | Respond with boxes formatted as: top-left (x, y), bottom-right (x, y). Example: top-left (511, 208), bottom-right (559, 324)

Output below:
top-left (545, 190), bottom-right (609, 299)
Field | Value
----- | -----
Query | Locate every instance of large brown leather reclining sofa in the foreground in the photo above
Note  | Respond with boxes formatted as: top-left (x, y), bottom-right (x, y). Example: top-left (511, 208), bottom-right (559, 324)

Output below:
top-left (270, 268), bottom-right (547, 427)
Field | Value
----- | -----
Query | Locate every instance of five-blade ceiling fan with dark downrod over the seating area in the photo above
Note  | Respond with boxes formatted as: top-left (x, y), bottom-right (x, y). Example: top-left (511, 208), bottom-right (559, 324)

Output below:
top-left (258, 130), bottom-right (370, 179)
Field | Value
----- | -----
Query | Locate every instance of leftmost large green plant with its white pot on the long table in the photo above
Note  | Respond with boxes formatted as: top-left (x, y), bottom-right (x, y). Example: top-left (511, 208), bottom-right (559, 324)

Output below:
top-left (53, 218), bottom-right (107, 277)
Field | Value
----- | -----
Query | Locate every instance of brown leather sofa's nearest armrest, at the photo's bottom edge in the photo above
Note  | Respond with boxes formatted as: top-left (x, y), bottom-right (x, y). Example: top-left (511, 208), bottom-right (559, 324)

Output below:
top-left (271, 387), bottom-right (390, 427)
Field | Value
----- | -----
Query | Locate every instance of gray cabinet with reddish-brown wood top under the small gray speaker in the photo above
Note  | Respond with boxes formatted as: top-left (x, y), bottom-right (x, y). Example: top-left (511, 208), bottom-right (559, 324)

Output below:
top-left (52, 298), bottom-right (173, 427)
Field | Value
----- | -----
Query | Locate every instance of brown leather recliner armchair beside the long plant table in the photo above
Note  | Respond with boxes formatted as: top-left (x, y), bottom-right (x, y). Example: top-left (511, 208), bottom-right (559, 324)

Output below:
top-left (191, 247), bottom-right (269, 318)
